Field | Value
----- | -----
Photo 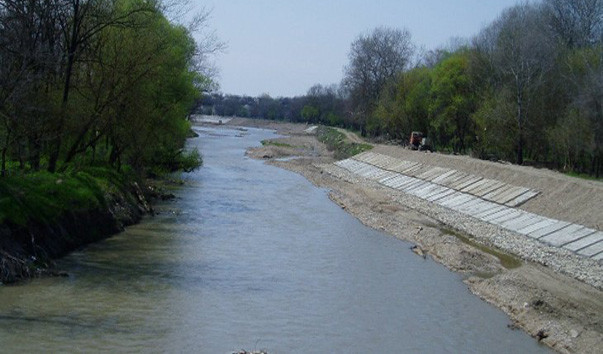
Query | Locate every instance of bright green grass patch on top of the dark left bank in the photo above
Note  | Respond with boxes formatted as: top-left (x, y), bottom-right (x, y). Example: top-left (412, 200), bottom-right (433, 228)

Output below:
top-left (0, 168), bottom-right (126, 225)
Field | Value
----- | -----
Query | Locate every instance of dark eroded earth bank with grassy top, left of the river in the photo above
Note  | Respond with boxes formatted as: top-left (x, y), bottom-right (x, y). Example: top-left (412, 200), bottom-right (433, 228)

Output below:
top-left (0, 168), bottom-right (175, 284)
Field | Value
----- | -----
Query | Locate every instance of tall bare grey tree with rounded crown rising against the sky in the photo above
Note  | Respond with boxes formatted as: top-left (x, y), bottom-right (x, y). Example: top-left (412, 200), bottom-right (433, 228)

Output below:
top-left (343, 27), bottom-right (414, 132)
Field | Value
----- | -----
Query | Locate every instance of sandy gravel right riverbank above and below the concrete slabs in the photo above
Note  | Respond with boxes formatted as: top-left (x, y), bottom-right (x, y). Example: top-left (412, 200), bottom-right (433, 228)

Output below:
top-left (229, 119), bottom-right (603, 353)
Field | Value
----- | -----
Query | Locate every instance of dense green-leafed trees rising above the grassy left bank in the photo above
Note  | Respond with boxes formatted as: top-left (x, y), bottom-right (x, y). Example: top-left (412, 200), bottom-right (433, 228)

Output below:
top-left (0, 0), bottom-right (217, 176)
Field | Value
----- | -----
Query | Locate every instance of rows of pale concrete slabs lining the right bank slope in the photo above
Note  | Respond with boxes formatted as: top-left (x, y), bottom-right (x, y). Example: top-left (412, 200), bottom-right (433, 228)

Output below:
top-left (336, 152), bottom-right (603, 262)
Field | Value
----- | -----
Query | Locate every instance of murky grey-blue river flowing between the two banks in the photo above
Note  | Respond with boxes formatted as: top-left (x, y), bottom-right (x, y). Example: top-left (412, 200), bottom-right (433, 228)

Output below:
top-left (0, 127), bottom-right (548, 354)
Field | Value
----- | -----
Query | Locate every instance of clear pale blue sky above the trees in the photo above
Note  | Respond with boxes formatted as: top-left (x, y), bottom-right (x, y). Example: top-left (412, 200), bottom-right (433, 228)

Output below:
top-left (194, 0), bottom-right (520, 97)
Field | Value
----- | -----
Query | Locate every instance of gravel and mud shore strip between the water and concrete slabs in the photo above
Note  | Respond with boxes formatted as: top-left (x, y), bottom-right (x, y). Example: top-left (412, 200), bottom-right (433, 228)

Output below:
top-left (229, 119), bottom-right (603, 353)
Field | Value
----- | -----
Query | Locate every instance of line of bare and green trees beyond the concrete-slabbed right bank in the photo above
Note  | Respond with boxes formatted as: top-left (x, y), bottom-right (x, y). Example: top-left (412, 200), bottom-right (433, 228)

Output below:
top-left (199, 0), bottom-right (603, 177)
